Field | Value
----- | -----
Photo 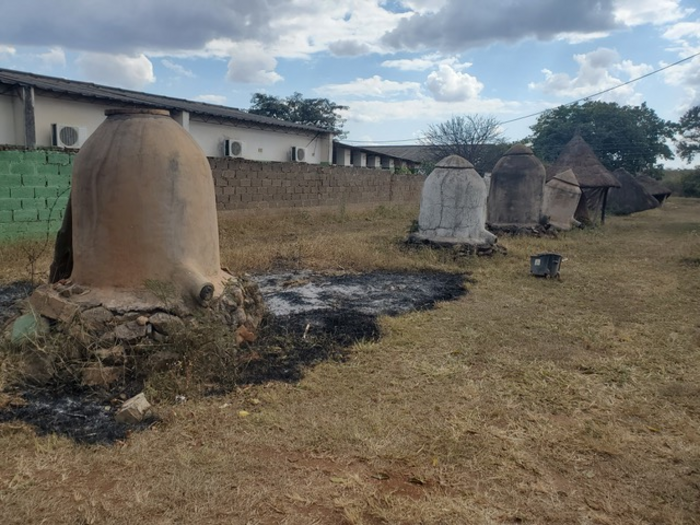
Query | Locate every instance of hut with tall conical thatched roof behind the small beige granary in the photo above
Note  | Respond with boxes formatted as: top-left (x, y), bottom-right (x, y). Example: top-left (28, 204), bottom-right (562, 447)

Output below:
top-left (547, 134), bottom-right (620, 223)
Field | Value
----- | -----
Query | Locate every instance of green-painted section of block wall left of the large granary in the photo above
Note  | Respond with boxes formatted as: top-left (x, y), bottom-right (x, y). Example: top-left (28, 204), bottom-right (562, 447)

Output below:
top-left (0, 149), bottom-right (75, 241)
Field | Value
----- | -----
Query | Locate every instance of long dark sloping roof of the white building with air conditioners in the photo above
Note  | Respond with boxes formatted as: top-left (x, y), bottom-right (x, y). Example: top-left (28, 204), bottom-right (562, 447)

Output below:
top-left (0, 68), bottom-right (333, 133)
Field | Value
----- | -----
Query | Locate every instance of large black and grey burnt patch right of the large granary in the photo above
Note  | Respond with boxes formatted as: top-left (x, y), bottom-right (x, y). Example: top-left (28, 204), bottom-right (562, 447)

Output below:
top-left (239, 270), bottom-right (466, 383)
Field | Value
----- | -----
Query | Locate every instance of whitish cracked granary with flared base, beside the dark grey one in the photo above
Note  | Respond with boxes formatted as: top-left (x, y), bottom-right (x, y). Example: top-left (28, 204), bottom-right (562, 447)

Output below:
top-left (409, 155), bottom-right (497, 248)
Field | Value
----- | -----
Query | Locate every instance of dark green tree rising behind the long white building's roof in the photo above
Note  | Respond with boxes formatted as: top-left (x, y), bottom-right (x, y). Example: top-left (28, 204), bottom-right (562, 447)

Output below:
top-left (248, 93), bottom-right (348, 134)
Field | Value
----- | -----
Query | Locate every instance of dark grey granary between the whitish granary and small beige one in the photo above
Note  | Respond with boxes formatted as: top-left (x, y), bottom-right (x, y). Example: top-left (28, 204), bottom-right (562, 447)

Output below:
top-left (487, 144), bottom-right (547, 228)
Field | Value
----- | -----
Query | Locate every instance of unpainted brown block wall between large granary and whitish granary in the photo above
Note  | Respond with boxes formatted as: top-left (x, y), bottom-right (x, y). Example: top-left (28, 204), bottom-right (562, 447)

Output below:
top-left (209, 158), bottom-right (425, 211)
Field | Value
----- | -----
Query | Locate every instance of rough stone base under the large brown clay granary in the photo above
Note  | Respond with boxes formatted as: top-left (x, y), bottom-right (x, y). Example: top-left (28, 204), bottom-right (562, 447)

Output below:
top-left (19, 277), bottom-right (266, 386)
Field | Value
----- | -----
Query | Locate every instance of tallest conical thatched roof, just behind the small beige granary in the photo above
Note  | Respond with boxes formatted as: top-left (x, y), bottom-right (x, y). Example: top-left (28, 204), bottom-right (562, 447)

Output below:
top-left (548, 135), bottom-right (620, 188)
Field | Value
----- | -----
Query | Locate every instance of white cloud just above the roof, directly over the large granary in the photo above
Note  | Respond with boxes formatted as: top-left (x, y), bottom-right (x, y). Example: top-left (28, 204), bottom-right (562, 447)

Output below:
top-left (76, 53), bottom-right (156, 90)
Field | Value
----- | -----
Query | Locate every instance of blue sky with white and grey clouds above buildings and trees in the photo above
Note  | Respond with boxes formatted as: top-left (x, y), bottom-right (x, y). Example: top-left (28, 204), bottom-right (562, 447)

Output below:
top-left (0, 0), bottom-right (700, 167)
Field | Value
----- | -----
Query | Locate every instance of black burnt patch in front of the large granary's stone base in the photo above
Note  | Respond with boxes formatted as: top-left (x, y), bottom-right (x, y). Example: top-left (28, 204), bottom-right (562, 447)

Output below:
top-left (0, 394), bottom-right (152, 445)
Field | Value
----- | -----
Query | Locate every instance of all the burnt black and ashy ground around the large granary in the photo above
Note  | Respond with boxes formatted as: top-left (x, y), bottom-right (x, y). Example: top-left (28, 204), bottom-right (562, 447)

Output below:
top-left (0, 270), bottom-right (466, 444)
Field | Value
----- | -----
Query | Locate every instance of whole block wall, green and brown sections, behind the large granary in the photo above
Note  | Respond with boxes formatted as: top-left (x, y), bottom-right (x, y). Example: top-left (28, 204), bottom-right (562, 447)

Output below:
top-left (0, 146), bottom-right (425, 242)
